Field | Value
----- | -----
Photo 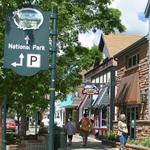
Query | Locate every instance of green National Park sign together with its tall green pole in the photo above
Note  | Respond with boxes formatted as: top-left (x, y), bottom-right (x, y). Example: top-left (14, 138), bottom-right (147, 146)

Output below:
top-left (4, 7), bottom-right (57, 150)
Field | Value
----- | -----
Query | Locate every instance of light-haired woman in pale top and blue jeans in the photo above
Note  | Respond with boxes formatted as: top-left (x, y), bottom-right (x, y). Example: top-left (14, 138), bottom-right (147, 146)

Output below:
top-left (118, 114), bottom-right (128, 150)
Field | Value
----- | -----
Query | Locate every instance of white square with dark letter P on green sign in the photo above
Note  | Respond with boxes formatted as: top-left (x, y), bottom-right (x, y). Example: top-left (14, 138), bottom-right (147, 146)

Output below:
top-left (27, 54), bottom-right (41, 68)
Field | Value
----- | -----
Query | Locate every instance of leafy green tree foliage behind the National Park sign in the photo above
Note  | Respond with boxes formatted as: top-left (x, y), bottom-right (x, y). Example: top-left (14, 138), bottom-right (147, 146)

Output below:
top-left (0, 0), bottom-right (125, 142)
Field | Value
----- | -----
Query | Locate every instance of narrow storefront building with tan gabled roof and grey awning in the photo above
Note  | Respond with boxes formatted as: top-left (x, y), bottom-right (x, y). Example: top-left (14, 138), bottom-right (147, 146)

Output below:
top-left (82, 34), bottom-right (140, 135)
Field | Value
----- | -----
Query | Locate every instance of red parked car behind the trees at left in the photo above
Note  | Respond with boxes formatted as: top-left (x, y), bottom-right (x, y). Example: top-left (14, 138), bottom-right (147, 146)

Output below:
top-left (6, 118), bottom-right (16, 132)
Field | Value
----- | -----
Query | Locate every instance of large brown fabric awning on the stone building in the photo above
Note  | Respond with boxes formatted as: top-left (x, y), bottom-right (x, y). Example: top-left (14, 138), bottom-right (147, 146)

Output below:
top-left (116, 72), bottom-right (140, 105)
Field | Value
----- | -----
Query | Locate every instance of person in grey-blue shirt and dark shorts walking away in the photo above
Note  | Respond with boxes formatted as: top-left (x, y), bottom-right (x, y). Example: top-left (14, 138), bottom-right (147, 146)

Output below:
top-left (66, 118), bottom-right (76, 145)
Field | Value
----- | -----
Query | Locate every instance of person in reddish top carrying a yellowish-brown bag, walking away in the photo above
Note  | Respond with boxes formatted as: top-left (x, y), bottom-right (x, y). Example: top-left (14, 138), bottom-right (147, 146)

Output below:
top-left (79, 113), bottom-right (92, 146)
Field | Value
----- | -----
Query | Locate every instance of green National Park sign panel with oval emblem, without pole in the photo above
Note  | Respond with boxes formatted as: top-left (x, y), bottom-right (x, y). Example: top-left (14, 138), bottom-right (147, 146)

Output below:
top-left (4, 8), bottom-right (50, 76)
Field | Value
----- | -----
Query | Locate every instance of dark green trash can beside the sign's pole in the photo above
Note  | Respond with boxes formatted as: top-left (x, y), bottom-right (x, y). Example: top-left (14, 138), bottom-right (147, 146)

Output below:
top-left (54, 127), bottom-right (67, 150)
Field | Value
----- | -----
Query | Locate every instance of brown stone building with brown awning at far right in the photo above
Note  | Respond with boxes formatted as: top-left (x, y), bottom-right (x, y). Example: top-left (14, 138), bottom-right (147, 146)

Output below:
top-left (114, 36), bottom-right (150, 139)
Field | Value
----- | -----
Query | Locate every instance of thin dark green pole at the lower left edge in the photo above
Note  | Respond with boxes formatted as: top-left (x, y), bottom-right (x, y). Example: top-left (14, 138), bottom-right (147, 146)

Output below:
top-left (3, 95), bottom-right (7, 150)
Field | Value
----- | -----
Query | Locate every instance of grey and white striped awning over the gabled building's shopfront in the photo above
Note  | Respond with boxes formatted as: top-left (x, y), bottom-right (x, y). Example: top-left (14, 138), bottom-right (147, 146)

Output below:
top-left (92, 87), bottom-right (110, 108)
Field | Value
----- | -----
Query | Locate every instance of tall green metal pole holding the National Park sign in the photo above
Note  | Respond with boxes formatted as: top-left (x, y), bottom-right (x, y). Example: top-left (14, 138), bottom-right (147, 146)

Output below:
top-left (48, 6), bottom-right (57, 150)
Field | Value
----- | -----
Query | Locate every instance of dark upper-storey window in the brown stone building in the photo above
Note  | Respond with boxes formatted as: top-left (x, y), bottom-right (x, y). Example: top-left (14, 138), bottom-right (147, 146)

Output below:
top-left (128, 54), bottom-right (139, 68)
